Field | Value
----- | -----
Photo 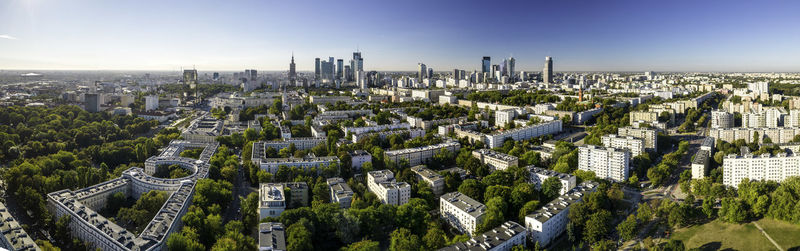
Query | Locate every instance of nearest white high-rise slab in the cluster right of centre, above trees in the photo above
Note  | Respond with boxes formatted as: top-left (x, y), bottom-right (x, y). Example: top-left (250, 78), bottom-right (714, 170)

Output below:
top-left (578, 145), bottom-right (631, 182)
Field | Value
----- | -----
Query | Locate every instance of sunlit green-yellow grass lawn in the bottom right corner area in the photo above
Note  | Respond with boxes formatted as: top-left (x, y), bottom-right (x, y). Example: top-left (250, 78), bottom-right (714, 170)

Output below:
top-left (671, 220), bottom-right (776, 250)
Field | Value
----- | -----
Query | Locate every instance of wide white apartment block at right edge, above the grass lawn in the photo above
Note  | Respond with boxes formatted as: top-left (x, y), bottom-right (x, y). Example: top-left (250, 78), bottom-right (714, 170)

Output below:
top-left (722, 153), bottom-right (800, 187)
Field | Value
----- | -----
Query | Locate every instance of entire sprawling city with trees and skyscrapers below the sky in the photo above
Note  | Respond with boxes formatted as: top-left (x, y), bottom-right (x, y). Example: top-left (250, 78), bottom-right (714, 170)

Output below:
top-left (0, 55), bottom-right (800, 251)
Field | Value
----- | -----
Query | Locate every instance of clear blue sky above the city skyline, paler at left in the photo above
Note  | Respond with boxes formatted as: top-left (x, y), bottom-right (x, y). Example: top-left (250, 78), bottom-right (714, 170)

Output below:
top-left (0, 0), bottom-right (800, 72)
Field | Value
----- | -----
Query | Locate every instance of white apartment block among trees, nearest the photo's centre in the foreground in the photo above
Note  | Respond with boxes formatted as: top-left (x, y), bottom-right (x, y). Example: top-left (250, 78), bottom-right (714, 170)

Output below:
top-left (367, 170), bottom-right (411, 206)
